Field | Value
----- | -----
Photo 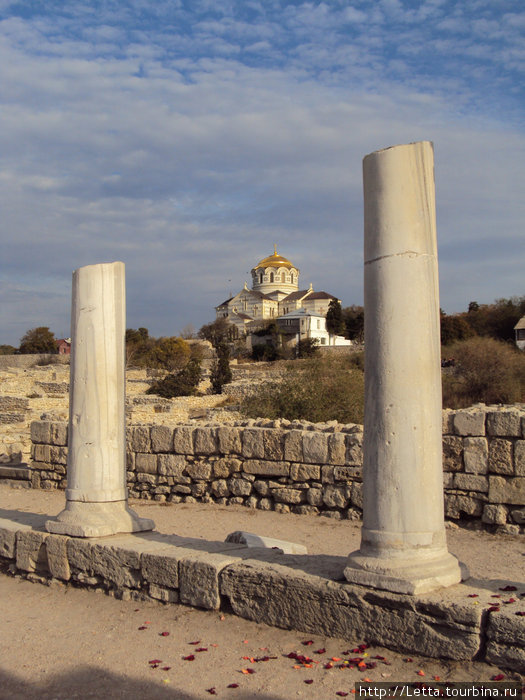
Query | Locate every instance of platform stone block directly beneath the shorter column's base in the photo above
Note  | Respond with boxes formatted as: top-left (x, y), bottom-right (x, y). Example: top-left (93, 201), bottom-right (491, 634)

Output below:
top-left (67, 538), bottom-right (140, 588)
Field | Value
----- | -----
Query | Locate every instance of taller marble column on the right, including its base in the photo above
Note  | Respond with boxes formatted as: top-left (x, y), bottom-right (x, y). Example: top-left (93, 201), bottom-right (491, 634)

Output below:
top-left (345, 141), bottom-right (461, 594)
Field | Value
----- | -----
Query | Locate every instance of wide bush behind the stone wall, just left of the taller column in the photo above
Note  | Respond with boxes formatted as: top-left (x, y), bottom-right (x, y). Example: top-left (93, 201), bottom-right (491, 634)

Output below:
top-left (241, 356), bottom-right (364, 423)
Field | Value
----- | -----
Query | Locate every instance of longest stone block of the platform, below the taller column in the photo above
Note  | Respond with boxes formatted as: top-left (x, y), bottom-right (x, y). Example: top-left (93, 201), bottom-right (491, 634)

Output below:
top-left (221, 557), bottom-right (481, 659)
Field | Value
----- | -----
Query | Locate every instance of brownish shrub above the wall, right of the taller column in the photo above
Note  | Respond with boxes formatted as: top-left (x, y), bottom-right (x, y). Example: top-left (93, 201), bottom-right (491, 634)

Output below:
top-left (443, 337), bottom-right (525, 408)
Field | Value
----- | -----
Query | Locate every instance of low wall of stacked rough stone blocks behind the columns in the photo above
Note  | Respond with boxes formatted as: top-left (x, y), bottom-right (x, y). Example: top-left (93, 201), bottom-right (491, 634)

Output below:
top-left (31, 405), bottom-right (525, 534)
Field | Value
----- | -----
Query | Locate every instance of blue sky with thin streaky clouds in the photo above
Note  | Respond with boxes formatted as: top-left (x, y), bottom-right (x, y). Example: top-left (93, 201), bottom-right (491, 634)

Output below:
top-left (0, 0), bottom-right (525, 345)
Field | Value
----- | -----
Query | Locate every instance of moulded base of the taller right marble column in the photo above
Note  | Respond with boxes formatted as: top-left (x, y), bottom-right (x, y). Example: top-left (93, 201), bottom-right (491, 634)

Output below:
top-left (344, 550), bottom-right (469, 595)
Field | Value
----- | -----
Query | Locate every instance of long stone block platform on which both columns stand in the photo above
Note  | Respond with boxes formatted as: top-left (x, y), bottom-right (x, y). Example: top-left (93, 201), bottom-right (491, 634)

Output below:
top-left (0, 511), bottom-right (525, 673)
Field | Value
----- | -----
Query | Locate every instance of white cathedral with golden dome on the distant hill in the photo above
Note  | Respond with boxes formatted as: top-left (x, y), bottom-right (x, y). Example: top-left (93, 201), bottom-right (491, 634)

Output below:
top-left (215, 248), bottom-right (352, 345)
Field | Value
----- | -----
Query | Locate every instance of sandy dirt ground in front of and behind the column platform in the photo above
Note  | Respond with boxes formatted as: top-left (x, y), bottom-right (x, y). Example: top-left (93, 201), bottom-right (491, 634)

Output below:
top-left (0, 486), bottom-right (525, 700)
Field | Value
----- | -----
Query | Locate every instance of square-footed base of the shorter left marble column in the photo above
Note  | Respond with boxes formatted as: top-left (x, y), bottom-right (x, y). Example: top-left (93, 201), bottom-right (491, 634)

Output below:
top-left (46, 501), bottom-right (155, 537)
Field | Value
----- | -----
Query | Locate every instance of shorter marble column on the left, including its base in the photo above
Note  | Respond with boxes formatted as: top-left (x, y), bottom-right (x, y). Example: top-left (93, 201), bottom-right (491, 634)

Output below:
top-left (46, 262), bottom-right (155, 537)
